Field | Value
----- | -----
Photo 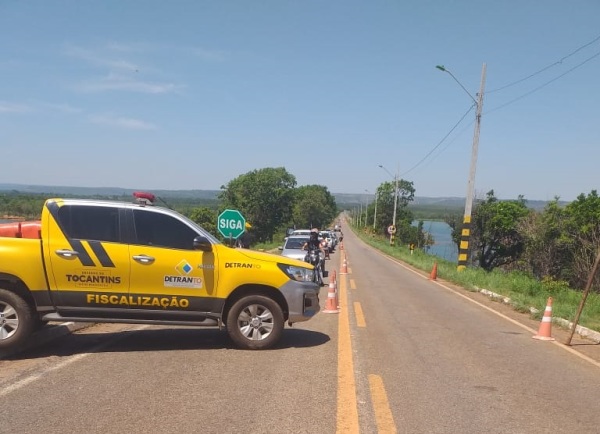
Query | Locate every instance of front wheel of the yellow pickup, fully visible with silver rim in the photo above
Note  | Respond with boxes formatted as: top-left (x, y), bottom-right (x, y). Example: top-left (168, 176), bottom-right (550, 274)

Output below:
top-left (227, 295), bottom-right (284, 350)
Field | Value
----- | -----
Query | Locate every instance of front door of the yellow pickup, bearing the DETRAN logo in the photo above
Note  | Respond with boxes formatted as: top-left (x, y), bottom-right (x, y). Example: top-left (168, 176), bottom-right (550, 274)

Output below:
top-left (130, 208), bottom-right (219, 320)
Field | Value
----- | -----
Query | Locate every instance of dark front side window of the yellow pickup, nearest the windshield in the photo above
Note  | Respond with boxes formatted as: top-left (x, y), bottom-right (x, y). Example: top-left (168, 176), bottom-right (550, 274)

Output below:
top-left (133, 210), bottom-right (198, 250)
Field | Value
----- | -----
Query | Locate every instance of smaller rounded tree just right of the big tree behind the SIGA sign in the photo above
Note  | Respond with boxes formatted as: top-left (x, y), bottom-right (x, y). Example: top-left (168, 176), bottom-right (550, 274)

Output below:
top-left (292, 185), bottom-right (338, 229)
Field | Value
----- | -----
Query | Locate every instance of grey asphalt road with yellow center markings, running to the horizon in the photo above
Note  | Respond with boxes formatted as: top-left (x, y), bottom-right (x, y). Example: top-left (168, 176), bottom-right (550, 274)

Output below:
top-left (0, 231), bottom-right (600, 433)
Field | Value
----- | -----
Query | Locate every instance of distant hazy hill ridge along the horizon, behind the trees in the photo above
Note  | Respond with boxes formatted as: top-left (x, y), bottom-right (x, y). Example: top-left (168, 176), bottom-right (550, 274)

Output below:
top-left (0, 183), bottom-right (567, 210)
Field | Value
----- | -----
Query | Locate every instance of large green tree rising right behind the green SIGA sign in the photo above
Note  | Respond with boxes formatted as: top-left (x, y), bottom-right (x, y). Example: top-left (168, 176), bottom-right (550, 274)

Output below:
top-left (219, 167), bottom-right (296, 242)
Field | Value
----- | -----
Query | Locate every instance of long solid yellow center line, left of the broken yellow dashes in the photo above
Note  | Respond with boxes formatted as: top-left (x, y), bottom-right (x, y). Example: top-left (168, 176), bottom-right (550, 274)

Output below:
top-left (336, 255), bottom-right (359, 433)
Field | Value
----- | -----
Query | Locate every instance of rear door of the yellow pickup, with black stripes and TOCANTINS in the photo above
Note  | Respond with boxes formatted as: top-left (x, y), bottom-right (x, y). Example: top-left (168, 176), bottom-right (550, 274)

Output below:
top-left (44, 201), bottom-right (130, 317)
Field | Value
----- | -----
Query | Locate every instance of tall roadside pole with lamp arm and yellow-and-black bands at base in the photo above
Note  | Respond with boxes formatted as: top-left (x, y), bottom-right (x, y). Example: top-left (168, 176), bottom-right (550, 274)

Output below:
top-left (436, 63), bottom-right (486, 271)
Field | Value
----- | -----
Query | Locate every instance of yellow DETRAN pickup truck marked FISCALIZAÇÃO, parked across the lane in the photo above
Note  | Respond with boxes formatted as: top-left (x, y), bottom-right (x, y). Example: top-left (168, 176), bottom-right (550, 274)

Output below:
top-left (0, 194), bottom-right (320, 349)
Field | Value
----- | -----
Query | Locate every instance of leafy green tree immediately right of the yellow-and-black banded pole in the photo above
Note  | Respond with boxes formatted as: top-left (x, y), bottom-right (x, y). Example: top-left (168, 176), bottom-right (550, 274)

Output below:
top-left (471, 190), bottom-right (529, 271)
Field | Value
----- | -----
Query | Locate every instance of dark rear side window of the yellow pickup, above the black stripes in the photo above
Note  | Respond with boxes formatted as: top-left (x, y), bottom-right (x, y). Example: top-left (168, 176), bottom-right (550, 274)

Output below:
top-left (58, 205), bottom-right (119, 243)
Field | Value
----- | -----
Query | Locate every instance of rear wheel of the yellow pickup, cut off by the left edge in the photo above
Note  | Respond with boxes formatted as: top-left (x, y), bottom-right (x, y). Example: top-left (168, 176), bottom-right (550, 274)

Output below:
top-left (0, 288), bottom-right (35, 349)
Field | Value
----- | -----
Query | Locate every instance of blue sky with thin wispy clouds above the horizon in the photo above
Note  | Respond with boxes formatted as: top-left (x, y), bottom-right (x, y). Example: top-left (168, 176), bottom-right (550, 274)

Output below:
top-left (0, 0), bottom-right (600, 200)
